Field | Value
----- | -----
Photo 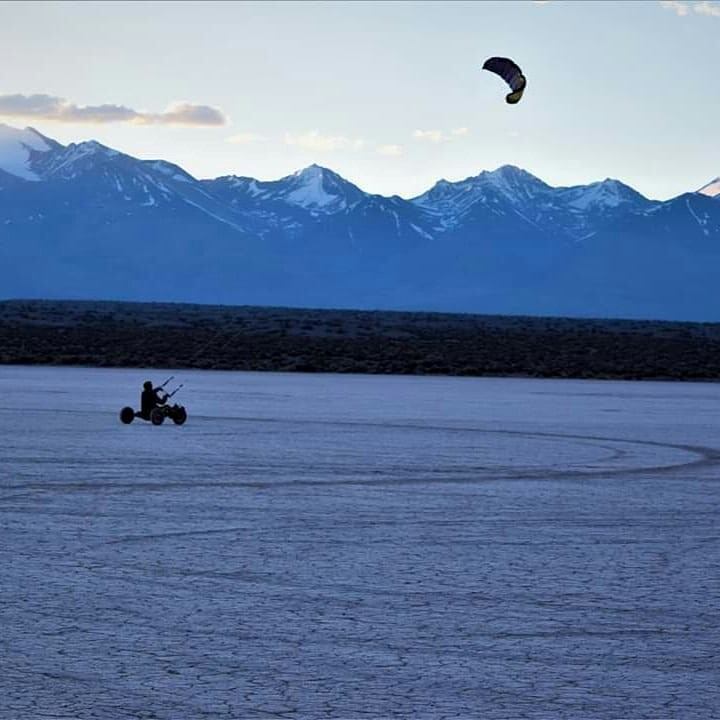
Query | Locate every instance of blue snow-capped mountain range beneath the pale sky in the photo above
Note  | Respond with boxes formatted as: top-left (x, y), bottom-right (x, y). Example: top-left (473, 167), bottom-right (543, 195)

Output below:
top-left (0, 124), bottom-right (720, 321)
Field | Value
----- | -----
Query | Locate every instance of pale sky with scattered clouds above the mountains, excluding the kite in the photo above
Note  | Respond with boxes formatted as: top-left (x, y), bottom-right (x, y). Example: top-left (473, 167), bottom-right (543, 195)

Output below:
top-left (0, 0), bottom-right (720, 199)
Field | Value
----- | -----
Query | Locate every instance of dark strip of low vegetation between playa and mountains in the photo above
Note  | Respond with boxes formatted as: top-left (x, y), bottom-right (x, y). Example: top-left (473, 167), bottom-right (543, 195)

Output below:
top-left (0, 300), bottom-right (720, 380)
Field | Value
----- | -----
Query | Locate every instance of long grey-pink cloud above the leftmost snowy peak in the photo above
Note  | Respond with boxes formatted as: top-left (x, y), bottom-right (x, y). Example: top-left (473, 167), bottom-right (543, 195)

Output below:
top-left (0, 94), bottom-right (227, 127)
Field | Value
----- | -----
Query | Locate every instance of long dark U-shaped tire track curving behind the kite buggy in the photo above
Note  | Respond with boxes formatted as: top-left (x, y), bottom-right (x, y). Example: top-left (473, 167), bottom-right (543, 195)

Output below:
top-left (5, 418), bottom-right (720, 500)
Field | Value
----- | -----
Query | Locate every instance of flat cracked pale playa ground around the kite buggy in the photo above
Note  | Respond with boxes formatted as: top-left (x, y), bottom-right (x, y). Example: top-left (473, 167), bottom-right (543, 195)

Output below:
top-left (0, 367), bottom-right (720, 720)
